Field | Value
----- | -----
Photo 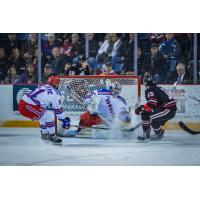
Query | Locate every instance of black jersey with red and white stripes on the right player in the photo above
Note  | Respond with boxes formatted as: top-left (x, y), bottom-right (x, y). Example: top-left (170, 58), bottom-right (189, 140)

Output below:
top-left (144, 85), bottom-right (176, 109)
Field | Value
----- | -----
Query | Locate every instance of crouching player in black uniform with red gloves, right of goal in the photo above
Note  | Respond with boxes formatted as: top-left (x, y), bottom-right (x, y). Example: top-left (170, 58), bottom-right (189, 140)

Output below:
top-left (135, 73), bottom-right (177, 141)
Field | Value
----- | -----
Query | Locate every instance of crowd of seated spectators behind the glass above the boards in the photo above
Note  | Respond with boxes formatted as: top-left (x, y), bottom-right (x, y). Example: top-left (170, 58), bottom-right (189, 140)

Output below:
top-left (0, 33), bottom-right (200, 84)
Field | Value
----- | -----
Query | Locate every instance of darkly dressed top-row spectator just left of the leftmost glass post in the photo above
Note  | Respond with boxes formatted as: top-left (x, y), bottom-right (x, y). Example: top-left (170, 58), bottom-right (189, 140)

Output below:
top-left (22, 33), bottom-right (38, 60)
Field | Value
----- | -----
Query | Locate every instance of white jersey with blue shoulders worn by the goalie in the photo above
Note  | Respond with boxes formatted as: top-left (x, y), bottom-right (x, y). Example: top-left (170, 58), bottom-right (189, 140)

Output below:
top-left (84, 89), bottom-right (126, 120)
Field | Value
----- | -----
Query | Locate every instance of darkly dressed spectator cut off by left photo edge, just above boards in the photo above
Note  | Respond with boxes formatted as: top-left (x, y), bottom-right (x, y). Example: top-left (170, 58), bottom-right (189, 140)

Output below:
top-left (0, 48), bottom-right (8, 83)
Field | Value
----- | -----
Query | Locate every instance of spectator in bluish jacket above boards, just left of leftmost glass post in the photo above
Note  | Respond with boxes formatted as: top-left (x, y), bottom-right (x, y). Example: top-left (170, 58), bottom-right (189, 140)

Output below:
top-left (16, 60), bottom-right (37, 84)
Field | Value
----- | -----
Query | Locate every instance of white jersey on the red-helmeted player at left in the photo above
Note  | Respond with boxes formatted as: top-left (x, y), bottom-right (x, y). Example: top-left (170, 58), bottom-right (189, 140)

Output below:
top-left (22, 85), bottom-right (65, 119)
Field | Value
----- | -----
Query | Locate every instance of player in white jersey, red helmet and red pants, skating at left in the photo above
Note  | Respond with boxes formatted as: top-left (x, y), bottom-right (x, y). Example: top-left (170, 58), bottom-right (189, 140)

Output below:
top-left (19, 76), bottom-right (70, 143)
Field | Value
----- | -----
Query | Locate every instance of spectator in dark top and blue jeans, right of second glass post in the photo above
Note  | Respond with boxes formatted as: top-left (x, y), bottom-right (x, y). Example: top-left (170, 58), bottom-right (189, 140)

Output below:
top-left (88, 33), bottom-right (99, 71)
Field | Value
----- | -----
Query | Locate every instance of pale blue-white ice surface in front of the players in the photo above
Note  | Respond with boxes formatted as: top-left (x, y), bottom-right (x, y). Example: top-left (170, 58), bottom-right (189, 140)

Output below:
top-left (0, 128), bottom-right (200, 166)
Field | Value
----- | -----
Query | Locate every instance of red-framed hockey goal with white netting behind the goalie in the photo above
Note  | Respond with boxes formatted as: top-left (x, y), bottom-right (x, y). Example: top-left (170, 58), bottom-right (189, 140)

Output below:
top-left (59, 75), bottom-right (141, 122)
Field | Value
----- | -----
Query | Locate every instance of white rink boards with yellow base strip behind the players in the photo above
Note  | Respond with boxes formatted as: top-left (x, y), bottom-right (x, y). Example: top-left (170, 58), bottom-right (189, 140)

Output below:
top-left (0, 85), bottom-right (200, 130)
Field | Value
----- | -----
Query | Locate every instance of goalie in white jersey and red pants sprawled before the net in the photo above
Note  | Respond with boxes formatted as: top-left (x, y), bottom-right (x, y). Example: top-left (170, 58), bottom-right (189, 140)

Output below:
top-left (59, 82), bottom-right (131, 136)
